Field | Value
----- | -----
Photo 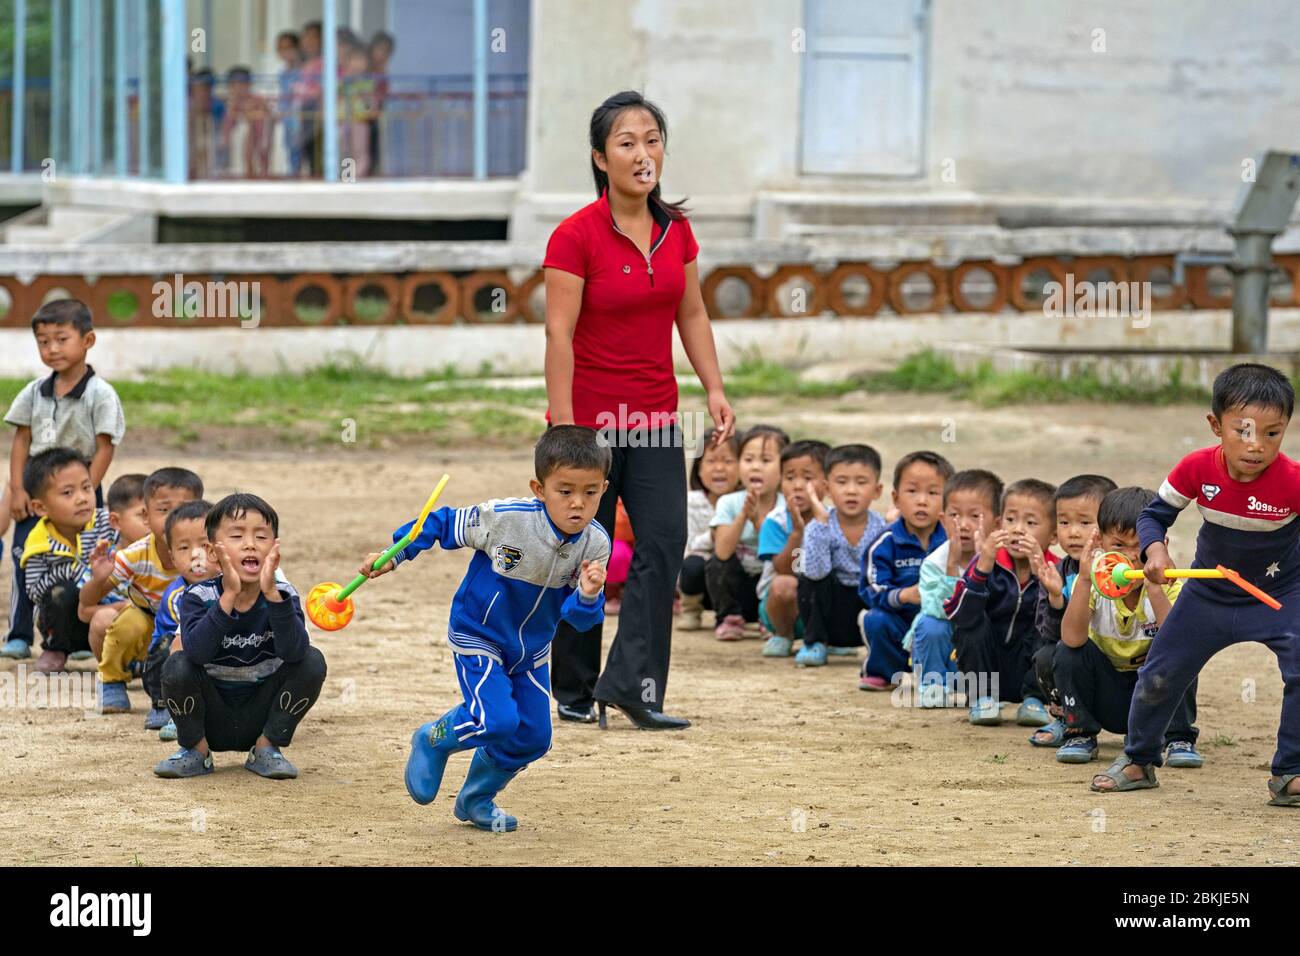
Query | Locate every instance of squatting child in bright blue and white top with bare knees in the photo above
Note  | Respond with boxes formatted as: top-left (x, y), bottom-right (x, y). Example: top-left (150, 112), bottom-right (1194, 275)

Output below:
top-left (758, 441), bottom-right (831, 657)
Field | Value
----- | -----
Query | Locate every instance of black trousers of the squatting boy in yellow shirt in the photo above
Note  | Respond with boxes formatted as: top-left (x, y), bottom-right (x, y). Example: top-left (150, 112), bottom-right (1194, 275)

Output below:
top-left (1052, 641), bottom-right (1200, 747)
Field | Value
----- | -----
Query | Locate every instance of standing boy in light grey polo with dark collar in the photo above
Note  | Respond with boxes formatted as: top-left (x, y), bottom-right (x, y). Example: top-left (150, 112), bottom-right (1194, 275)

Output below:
top-left (0, 299), bottom-right (126, 674)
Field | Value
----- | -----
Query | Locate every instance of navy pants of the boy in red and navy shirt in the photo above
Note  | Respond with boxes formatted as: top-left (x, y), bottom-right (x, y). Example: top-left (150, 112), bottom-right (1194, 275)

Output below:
top-left (1125, 580), bottom-right (1300, 777)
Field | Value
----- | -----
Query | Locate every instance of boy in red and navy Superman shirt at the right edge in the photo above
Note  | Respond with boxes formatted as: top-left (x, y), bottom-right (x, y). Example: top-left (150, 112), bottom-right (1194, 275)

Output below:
top-left (1092, 364), bottom-right (1300, 806)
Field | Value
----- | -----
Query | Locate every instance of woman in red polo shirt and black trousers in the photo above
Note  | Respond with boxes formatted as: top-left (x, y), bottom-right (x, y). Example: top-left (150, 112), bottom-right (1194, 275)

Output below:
top-left (543, 91), bottom-right (736, 730)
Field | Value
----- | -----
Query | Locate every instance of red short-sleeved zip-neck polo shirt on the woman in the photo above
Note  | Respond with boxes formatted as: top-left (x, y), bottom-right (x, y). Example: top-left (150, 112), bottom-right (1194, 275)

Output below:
top-left (542, 191), bottom-right (699, 429)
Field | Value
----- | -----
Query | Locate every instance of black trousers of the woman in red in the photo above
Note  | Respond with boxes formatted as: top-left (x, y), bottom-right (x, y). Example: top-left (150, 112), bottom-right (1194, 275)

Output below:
top-left (551, 427), bottom-right (686, 710)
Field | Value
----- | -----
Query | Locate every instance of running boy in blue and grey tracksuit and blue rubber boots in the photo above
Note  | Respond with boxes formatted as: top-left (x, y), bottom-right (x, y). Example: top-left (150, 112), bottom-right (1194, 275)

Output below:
top-left (360, 425), bottom-right (611, 832)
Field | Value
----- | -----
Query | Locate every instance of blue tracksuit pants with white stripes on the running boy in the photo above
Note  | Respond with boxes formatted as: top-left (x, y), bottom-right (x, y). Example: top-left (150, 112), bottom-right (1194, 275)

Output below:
top-left (454, 654), bottom-right (551, 770)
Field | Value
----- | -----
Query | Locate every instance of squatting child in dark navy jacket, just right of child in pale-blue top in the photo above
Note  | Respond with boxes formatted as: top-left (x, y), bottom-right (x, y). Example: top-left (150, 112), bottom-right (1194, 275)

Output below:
top-left (944, 479), bottom-right (1058, 727)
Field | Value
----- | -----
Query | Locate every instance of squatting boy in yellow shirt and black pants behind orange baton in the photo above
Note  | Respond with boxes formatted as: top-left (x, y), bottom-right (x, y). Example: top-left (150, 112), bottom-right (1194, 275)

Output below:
top-left (1043, 488), bottom-right (1203, 767)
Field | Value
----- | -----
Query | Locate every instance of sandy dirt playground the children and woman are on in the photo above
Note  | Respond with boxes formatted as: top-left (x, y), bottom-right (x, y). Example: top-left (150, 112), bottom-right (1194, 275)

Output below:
top-left (0, 395), bottom-right (1300, 865)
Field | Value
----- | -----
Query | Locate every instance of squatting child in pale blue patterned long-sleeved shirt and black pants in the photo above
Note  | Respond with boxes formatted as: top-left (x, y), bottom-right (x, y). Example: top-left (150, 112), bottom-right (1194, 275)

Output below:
top-left (794, 445), bottom-right (885, 667)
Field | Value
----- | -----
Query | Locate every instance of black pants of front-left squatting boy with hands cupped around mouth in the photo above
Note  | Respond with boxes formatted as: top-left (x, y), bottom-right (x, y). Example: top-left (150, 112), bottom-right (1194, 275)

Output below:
top-left (163, 648), bottom-right (325, 750)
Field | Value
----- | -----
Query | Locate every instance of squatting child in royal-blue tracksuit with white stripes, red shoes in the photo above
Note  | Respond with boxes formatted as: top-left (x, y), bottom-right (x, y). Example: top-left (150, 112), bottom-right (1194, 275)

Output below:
top-left (858, 451), bottom-right (953, 691)
